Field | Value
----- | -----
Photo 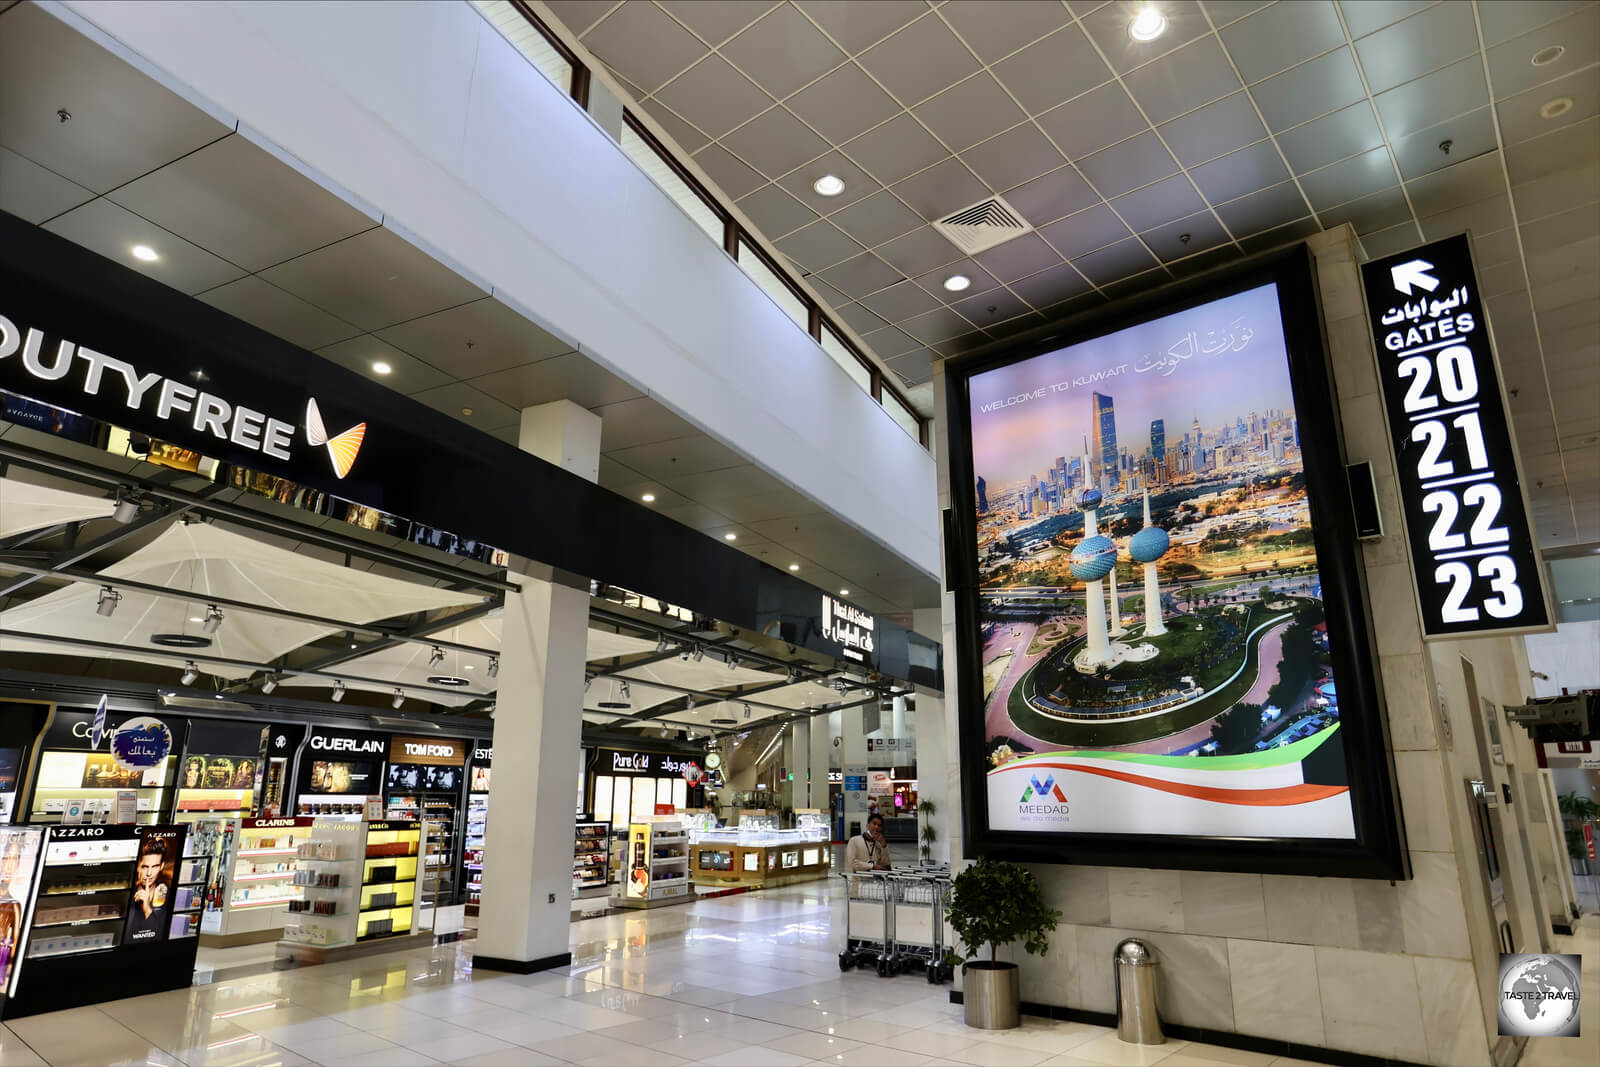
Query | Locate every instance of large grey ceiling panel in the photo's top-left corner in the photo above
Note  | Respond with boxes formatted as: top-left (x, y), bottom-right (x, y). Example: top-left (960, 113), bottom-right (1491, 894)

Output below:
top-left (0, 3), bottom-right (232, 192)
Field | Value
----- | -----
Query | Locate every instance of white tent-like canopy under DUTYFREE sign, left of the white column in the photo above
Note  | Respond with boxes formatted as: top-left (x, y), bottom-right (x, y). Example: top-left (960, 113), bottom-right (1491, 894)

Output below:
top-left (0, 523), bottom-right (480, 678)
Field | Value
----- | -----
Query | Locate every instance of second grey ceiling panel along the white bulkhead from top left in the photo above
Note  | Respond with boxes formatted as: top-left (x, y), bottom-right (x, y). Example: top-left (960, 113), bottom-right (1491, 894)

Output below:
top-left (107, 134), bottom-right (379, 272)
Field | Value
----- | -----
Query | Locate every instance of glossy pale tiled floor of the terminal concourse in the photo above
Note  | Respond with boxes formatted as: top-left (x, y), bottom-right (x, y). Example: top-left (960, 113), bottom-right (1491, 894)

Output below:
top-left (0, 883), bottom-right (1600, 1067)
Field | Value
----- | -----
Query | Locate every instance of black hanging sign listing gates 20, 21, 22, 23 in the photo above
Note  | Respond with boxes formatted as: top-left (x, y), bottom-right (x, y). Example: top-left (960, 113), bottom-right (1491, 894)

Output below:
top-left (1362, 235), bottom-right (1550, 637)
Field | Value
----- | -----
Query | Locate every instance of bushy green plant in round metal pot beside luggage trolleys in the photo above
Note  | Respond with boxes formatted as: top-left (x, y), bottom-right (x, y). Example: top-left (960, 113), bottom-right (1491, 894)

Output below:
top-left (949, 856), bottom-right (1061, 1030)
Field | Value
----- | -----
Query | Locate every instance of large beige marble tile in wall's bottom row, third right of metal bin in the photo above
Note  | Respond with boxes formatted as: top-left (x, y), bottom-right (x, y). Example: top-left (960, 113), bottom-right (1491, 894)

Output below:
top-left (1317, 949), bottom-right (1427, 1062)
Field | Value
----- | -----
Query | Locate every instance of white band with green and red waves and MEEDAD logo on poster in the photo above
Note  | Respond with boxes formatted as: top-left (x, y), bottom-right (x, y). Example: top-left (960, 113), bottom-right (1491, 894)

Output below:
top-left (989, 725), bottom-right (1355, 840)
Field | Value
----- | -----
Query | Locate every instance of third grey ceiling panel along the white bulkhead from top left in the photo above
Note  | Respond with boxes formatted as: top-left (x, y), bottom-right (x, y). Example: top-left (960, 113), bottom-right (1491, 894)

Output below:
top-left (261, 227), bottom-right (488, 330)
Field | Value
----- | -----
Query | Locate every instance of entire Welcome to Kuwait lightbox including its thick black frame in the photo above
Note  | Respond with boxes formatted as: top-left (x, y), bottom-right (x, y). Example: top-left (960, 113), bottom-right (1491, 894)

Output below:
top-left (949, 250), bottom-right (1403, 878)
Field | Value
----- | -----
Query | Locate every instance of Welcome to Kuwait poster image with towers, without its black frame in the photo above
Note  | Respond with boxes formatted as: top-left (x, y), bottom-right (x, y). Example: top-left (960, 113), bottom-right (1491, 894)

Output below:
top-left (968, 285), bottom-right (1355, 840)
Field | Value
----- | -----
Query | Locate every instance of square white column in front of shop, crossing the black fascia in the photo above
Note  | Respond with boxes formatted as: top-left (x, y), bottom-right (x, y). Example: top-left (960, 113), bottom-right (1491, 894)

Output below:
top-left (474, 400), bottom-right (600, 973)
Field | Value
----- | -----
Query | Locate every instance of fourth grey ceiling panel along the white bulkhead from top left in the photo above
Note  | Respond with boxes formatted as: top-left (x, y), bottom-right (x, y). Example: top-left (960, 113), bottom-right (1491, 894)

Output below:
top-left (378, 296), bottom-right (573, 378)
